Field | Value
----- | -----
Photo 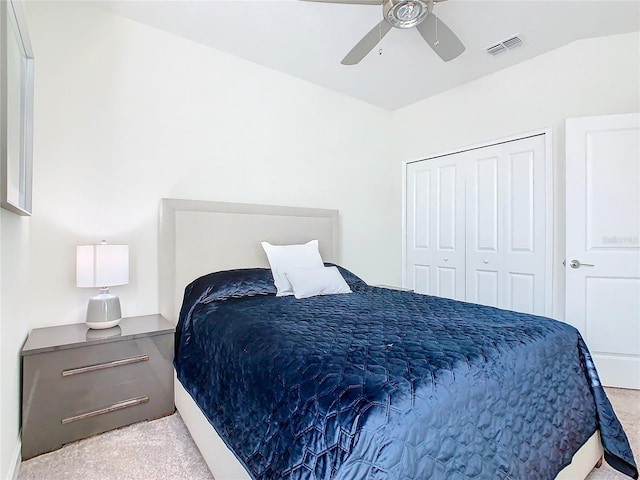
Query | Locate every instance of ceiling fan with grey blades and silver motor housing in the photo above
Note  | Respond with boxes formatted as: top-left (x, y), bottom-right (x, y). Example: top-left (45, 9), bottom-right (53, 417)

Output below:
top-left (303, 0), bottom-right (464, 65)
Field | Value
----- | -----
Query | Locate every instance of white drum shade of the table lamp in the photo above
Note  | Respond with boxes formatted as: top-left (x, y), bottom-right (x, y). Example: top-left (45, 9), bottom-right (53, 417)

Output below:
top-left (76, 244), bottom-right (129, 288)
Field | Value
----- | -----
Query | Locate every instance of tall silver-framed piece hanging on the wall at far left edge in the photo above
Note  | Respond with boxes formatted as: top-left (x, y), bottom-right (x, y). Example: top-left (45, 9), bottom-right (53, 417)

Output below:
top-left (0, 0), bottom-right (33, 215)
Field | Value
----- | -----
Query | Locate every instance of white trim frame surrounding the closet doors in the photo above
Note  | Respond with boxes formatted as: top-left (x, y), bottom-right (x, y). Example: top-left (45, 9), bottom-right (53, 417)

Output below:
top-left (402, 127), bottom-right (564, 317)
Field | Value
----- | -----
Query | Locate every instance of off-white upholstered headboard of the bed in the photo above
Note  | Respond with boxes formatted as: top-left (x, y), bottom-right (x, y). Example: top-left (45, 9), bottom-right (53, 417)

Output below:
top-left (158, 199), bottom-right (339, 323)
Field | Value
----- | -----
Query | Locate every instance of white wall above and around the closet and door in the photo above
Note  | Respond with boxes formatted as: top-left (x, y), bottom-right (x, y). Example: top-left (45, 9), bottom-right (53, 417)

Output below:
top-left (392, 33), bottom-right (640, 319)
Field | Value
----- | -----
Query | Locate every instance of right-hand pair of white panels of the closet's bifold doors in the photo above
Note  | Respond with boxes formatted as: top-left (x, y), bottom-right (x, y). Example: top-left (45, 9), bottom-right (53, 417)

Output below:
top-left (464, 135), bottom-right (546, 315)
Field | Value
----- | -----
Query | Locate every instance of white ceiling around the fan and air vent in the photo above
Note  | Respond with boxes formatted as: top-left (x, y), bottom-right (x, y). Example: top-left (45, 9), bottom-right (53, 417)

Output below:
top-left (99, 0), bottom-right (640, 110)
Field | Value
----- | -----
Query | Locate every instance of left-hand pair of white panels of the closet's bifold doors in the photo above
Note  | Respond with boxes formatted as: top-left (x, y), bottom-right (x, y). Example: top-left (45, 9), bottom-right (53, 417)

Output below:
top-left (405, 155), bottom-right (465, 300)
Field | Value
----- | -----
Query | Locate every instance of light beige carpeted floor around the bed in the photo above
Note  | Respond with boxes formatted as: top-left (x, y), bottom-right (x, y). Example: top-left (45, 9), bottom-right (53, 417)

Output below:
top-left (18, 389), bottom-right (640, 480)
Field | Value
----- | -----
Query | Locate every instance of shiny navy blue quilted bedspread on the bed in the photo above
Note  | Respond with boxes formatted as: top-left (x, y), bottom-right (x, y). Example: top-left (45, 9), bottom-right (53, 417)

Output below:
top-left (175, 269), bottom-right (638, 480)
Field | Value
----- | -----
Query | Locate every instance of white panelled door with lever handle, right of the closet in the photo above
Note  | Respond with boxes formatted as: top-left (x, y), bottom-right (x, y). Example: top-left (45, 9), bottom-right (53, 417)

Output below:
top-left (566, 114), bottom-right (640, 389)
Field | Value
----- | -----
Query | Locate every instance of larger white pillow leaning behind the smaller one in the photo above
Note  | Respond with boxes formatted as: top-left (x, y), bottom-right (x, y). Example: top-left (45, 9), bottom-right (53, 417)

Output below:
top-left (262, 240), bottom-right (324, 297)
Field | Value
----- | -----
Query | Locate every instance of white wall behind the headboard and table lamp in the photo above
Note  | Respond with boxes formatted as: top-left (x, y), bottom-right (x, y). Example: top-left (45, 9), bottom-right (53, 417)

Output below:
top-left (27, 2), bottom-right (399, 326)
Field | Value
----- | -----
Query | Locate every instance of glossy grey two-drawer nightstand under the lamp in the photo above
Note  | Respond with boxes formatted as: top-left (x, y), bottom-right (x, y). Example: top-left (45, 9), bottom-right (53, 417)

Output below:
top-left (22, 315), bottom-right (175, 459)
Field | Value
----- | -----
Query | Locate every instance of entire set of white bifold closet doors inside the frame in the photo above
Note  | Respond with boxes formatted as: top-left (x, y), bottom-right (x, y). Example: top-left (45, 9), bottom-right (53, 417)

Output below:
top-left (404, 134), bottom-right (550, 315)
